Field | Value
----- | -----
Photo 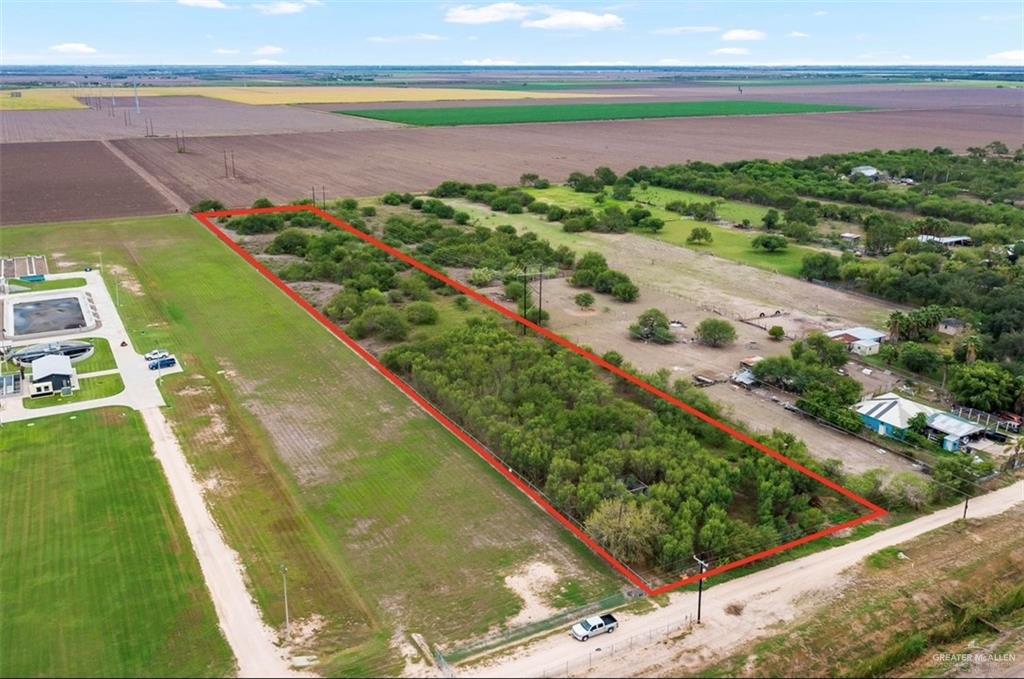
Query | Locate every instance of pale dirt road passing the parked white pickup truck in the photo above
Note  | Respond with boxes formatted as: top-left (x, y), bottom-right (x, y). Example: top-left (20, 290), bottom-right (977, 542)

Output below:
top-left (468, 481), bottom-right (1024, 677)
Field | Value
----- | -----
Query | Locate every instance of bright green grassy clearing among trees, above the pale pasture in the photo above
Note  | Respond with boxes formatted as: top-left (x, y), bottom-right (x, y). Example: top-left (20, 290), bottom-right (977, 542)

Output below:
top-left (524, 186), bottom-right (813, 277)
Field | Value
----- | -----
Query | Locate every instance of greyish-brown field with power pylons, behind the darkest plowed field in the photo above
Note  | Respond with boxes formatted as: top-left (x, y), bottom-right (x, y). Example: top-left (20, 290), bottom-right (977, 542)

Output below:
top-left (0, 96), bottom-right (393, 143)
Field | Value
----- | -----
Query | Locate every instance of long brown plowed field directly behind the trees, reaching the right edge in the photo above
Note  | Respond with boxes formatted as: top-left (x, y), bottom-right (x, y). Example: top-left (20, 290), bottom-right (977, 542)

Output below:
top-left (108, 107), bottom-right (1021, 206)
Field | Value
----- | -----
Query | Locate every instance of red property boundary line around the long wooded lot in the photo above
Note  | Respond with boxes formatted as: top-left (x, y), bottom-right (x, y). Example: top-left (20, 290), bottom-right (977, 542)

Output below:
top-left (193, 205), bottom-right (889, 596)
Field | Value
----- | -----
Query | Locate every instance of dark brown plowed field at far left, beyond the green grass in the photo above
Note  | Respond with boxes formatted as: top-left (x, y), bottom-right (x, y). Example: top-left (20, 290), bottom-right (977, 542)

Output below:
top-left (0, 141), bottom-right (173, 224)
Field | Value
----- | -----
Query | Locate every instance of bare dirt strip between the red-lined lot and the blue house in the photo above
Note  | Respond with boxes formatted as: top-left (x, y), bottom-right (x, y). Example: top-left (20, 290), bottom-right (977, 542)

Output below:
top-left (707, 384), bottom-right (914, 474)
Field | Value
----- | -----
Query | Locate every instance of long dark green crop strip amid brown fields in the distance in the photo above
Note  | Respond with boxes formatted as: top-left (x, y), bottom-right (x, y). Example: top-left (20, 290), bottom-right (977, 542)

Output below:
top-left (335, 101), bottom-right (867, 127)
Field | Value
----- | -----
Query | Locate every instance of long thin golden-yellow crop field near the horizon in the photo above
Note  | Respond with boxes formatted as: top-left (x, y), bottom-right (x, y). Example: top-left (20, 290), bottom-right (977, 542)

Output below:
top-left (0, 86), bottom-right (593, 111)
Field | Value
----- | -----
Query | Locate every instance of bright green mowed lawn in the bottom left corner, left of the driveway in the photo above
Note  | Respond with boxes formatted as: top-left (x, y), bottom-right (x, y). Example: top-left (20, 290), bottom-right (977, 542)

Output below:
top-left (0, 408), bottom-right (234, 677)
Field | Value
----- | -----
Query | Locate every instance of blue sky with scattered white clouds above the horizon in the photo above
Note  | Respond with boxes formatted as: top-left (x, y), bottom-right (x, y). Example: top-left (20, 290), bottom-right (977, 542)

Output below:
top-left (0, 0), bottom-right (1024, 67)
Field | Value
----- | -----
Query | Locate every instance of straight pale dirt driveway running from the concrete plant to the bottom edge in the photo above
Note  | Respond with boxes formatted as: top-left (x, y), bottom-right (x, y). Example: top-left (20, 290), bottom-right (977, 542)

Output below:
top-left (141, 408), bottom-right (301, 677)
